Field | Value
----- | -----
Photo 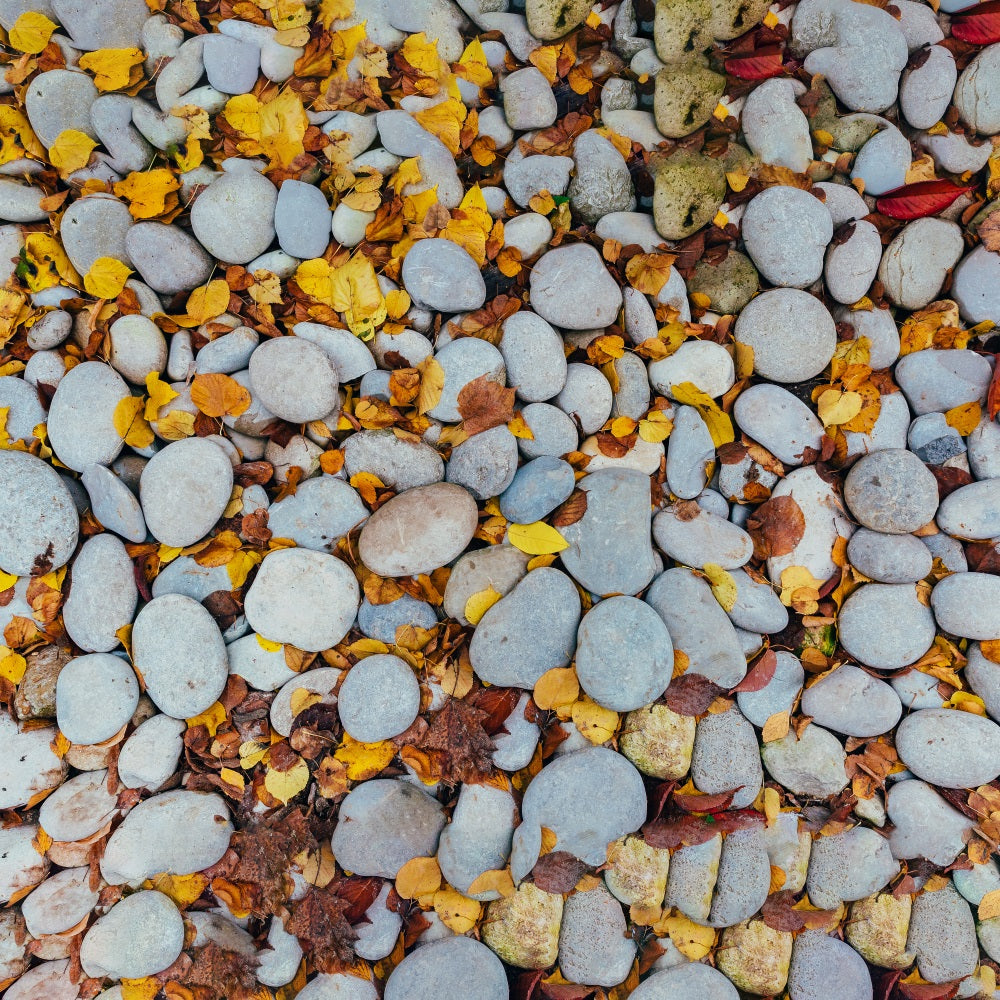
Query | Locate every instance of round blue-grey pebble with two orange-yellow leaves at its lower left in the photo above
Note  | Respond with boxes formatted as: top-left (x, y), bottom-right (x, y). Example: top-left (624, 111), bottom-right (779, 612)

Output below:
top-left (575, 597), bottom-right (674, 712)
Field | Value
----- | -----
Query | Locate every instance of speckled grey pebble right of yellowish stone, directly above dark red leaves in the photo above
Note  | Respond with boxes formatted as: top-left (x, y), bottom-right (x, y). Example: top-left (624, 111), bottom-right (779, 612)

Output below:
top-left (691, 709), bottom-right (764, 809)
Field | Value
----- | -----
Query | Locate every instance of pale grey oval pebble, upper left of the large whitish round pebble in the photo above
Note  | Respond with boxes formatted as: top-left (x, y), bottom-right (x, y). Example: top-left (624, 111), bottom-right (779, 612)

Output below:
top-left (139, 438), bottom-right (233, 547)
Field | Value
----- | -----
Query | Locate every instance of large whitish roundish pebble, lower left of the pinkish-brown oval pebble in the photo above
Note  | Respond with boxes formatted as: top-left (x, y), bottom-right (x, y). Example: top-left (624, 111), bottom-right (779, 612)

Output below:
top-left (244, 548), bottom-right (360, 652)
